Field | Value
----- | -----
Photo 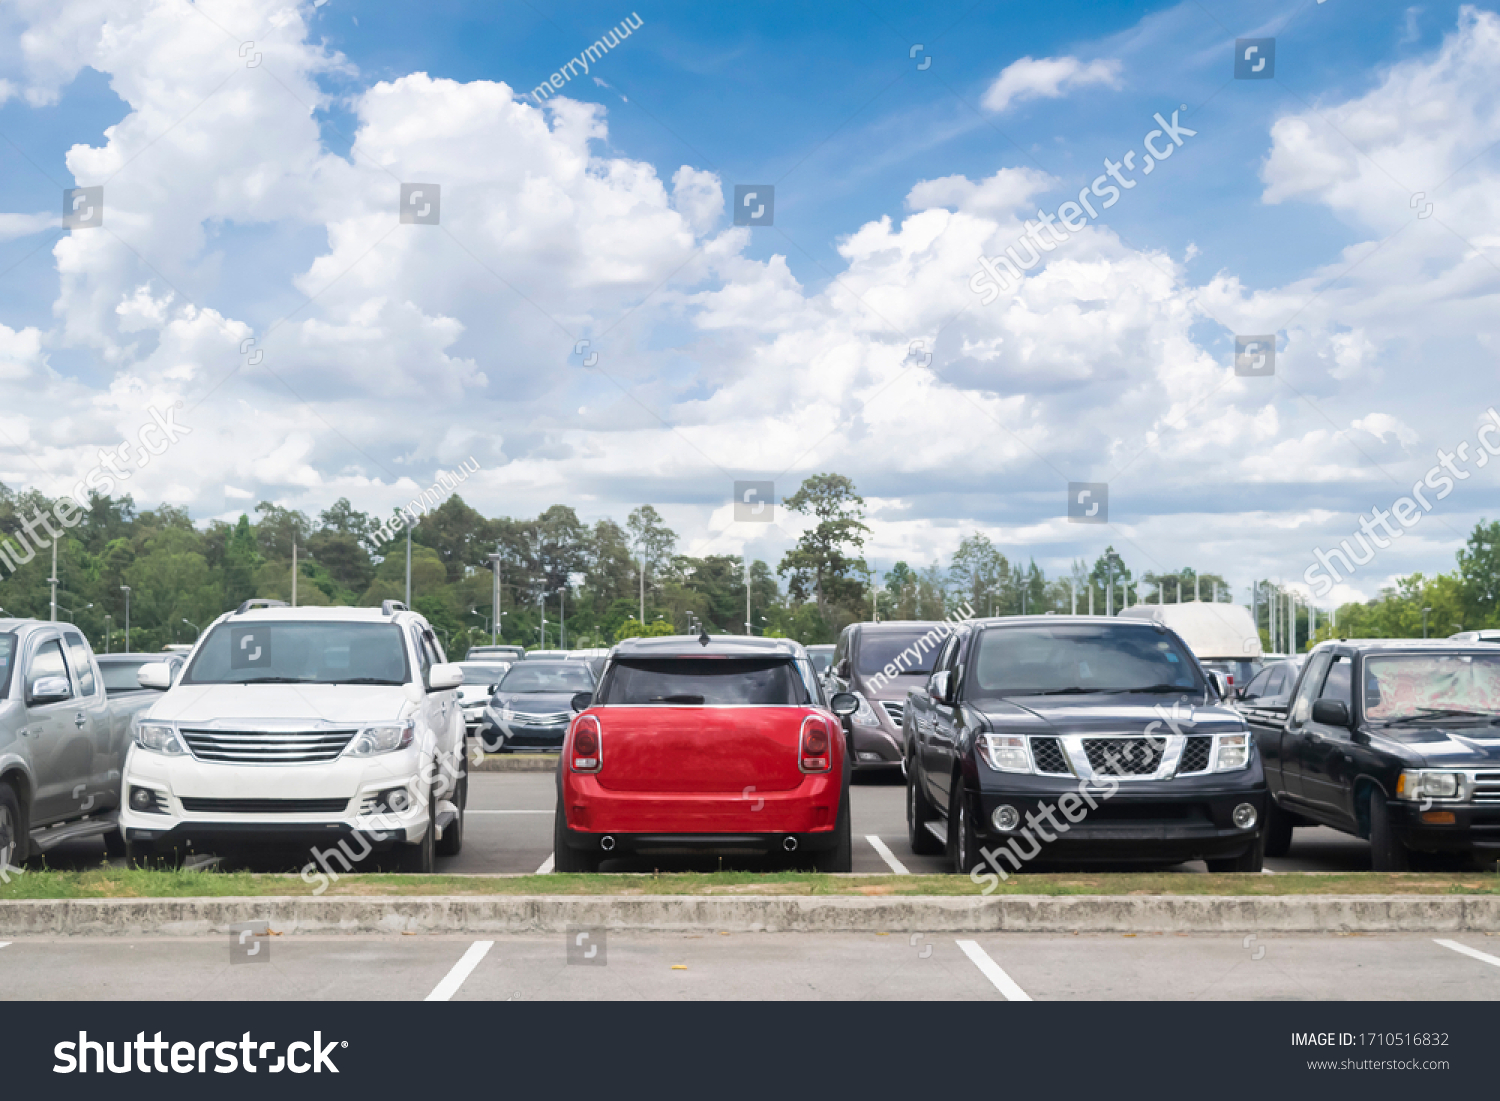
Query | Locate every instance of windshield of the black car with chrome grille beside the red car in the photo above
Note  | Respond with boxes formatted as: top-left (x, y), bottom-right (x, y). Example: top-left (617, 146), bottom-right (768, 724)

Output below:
top-left (965, 624), bottom-right (1205, 698)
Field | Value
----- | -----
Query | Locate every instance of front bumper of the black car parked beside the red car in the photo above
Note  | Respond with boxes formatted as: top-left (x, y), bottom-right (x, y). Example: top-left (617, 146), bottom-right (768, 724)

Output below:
top-left (950, 761), bottom-right (1269, 872)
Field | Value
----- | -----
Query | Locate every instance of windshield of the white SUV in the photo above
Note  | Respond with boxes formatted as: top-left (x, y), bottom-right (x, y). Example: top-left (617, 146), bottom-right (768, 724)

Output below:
top-left (182, 620), bottom-right (411, 684)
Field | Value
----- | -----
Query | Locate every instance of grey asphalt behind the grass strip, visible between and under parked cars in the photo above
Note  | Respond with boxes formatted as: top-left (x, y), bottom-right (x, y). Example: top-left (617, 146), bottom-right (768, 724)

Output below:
top-left (35, 773), bottom-right (1370, 875)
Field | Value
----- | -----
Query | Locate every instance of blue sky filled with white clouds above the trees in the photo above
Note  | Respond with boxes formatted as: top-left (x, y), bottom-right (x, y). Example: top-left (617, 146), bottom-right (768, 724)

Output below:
top-left (0, 0), bottom-right (1500, 596)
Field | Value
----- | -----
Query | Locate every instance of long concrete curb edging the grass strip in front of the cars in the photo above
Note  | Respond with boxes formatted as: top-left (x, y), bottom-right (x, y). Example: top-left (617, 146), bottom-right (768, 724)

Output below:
top-left (0, 896), bottom-right (1500, 938)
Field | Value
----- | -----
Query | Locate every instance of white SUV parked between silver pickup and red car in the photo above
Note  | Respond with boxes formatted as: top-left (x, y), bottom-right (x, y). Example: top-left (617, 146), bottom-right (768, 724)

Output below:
top-left (120, 600), bottom-right (468, 878)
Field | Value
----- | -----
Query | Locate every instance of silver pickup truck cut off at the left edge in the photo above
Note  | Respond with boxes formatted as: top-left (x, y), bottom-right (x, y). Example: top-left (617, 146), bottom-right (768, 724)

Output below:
top-left (0, 620), bottom-right (161, 873)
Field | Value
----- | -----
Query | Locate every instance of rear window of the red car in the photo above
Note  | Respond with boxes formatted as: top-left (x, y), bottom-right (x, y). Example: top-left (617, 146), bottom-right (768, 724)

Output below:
top-left (594, 657), bottom-right (812, 707)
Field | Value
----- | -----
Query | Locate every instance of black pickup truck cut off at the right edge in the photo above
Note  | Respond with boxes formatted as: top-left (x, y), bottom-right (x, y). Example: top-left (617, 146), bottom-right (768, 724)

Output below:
top-left (1247, 639), bottom-right (1500, 872)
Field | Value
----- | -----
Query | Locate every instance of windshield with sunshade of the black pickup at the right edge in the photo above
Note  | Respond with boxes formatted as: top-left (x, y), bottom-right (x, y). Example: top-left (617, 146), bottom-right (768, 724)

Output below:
top-left (1365, 653), bottom-right (1500, 723)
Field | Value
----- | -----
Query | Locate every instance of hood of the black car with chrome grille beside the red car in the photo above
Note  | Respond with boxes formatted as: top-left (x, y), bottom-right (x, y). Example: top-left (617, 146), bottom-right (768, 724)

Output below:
top-left (969, 693), bottom-right (1245, 735)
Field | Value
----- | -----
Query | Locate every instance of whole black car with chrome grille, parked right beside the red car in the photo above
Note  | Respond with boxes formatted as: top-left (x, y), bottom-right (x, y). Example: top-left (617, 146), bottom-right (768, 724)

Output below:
top-left (905, 615), bottom-right (1268, 884)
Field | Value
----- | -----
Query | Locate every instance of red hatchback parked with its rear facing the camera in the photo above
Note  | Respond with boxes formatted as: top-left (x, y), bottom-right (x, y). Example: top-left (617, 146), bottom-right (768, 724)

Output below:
top-left (554, 635), bottom-right (858, 872)
